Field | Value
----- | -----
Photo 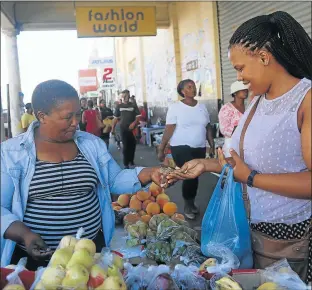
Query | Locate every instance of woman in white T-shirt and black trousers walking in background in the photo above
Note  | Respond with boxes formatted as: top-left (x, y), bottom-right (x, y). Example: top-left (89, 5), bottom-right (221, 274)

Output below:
top-left (158, 79), bottom-right (214, 219)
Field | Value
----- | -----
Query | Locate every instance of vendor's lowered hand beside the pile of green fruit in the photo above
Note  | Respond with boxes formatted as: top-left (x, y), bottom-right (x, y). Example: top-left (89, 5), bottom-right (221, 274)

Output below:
top-left (24, 232), bottom-right (53, 260)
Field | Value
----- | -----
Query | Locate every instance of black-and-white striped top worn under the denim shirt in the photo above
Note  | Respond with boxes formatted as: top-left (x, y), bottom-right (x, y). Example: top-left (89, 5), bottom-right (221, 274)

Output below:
top-left (20, 152), bottom-right (101, 250)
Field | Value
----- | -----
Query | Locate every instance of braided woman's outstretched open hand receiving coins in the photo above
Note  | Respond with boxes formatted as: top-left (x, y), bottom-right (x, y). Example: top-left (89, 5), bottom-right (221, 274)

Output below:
top-left (168, 159), bottom-right (206, 180)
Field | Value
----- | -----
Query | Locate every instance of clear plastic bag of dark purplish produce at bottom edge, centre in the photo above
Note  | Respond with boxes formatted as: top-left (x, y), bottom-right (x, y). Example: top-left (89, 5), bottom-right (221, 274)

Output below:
top-left (147, 265), bottom-right (179, 290)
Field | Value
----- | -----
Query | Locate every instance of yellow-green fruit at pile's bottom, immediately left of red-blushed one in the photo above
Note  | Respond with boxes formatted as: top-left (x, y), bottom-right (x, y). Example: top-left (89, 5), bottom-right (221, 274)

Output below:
top-left (62, 264), bottom-right (89, 289)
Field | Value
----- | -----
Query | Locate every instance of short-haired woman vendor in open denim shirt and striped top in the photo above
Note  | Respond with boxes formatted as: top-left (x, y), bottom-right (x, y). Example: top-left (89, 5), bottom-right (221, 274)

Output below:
top-left (1, 80), bottom-right (167, 270)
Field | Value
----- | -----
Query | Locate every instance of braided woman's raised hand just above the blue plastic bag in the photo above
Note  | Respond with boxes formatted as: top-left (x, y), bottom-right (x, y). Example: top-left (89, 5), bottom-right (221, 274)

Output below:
top-left (218, 148), bottom-right (251, 183)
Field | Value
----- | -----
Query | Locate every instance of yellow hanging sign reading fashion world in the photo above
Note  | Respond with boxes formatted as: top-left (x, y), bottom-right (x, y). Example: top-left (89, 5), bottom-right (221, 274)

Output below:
top-left (76, 6), bottom-right (157, 37)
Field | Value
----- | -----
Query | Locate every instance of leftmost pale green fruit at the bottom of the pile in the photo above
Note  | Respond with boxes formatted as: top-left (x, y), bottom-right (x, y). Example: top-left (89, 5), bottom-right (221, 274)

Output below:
top-left (41, 266), bottom-right (65, 290)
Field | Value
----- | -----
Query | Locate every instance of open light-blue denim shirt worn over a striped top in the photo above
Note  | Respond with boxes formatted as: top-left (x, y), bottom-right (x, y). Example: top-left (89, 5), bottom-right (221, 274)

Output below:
top-left (1, 121), bottom-right (143, 267)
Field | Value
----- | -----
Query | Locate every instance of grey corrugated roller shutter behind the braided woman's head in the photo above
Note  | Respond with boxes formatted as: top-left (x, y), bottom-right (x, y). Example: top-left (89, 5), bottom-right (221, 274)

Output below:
top-left (217, 1), bottom-right (311, 103)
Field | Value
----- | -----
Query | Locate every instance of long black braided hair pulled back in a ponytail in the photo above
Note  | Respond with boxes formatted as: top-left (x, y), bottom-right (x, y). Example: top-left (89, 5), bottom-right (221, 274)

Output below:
top-left (229, 11), bottom-right (312, 80)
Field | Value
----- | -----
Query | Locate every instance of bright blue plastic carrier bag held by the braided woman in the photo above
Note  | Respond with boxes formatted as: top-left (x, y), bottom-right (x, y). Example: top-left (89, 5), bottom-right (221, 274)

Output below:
top-left (201, 164), bottom-right (253, 269)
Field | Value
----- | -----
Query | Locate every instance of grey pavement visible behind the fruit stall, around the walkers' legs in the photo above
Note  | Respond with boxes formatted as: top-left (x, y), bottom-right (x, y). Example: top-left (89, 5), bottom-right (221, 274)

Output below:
top-left (109, 139), bottom-right (218, 234)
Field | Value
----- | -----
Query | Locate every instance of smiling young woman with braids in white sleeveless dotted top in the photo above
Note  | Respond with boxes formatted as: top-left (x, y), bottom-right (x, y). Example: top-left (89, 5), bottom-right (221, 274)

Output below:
top-left (172, 11), bottom-right (312, 281)
